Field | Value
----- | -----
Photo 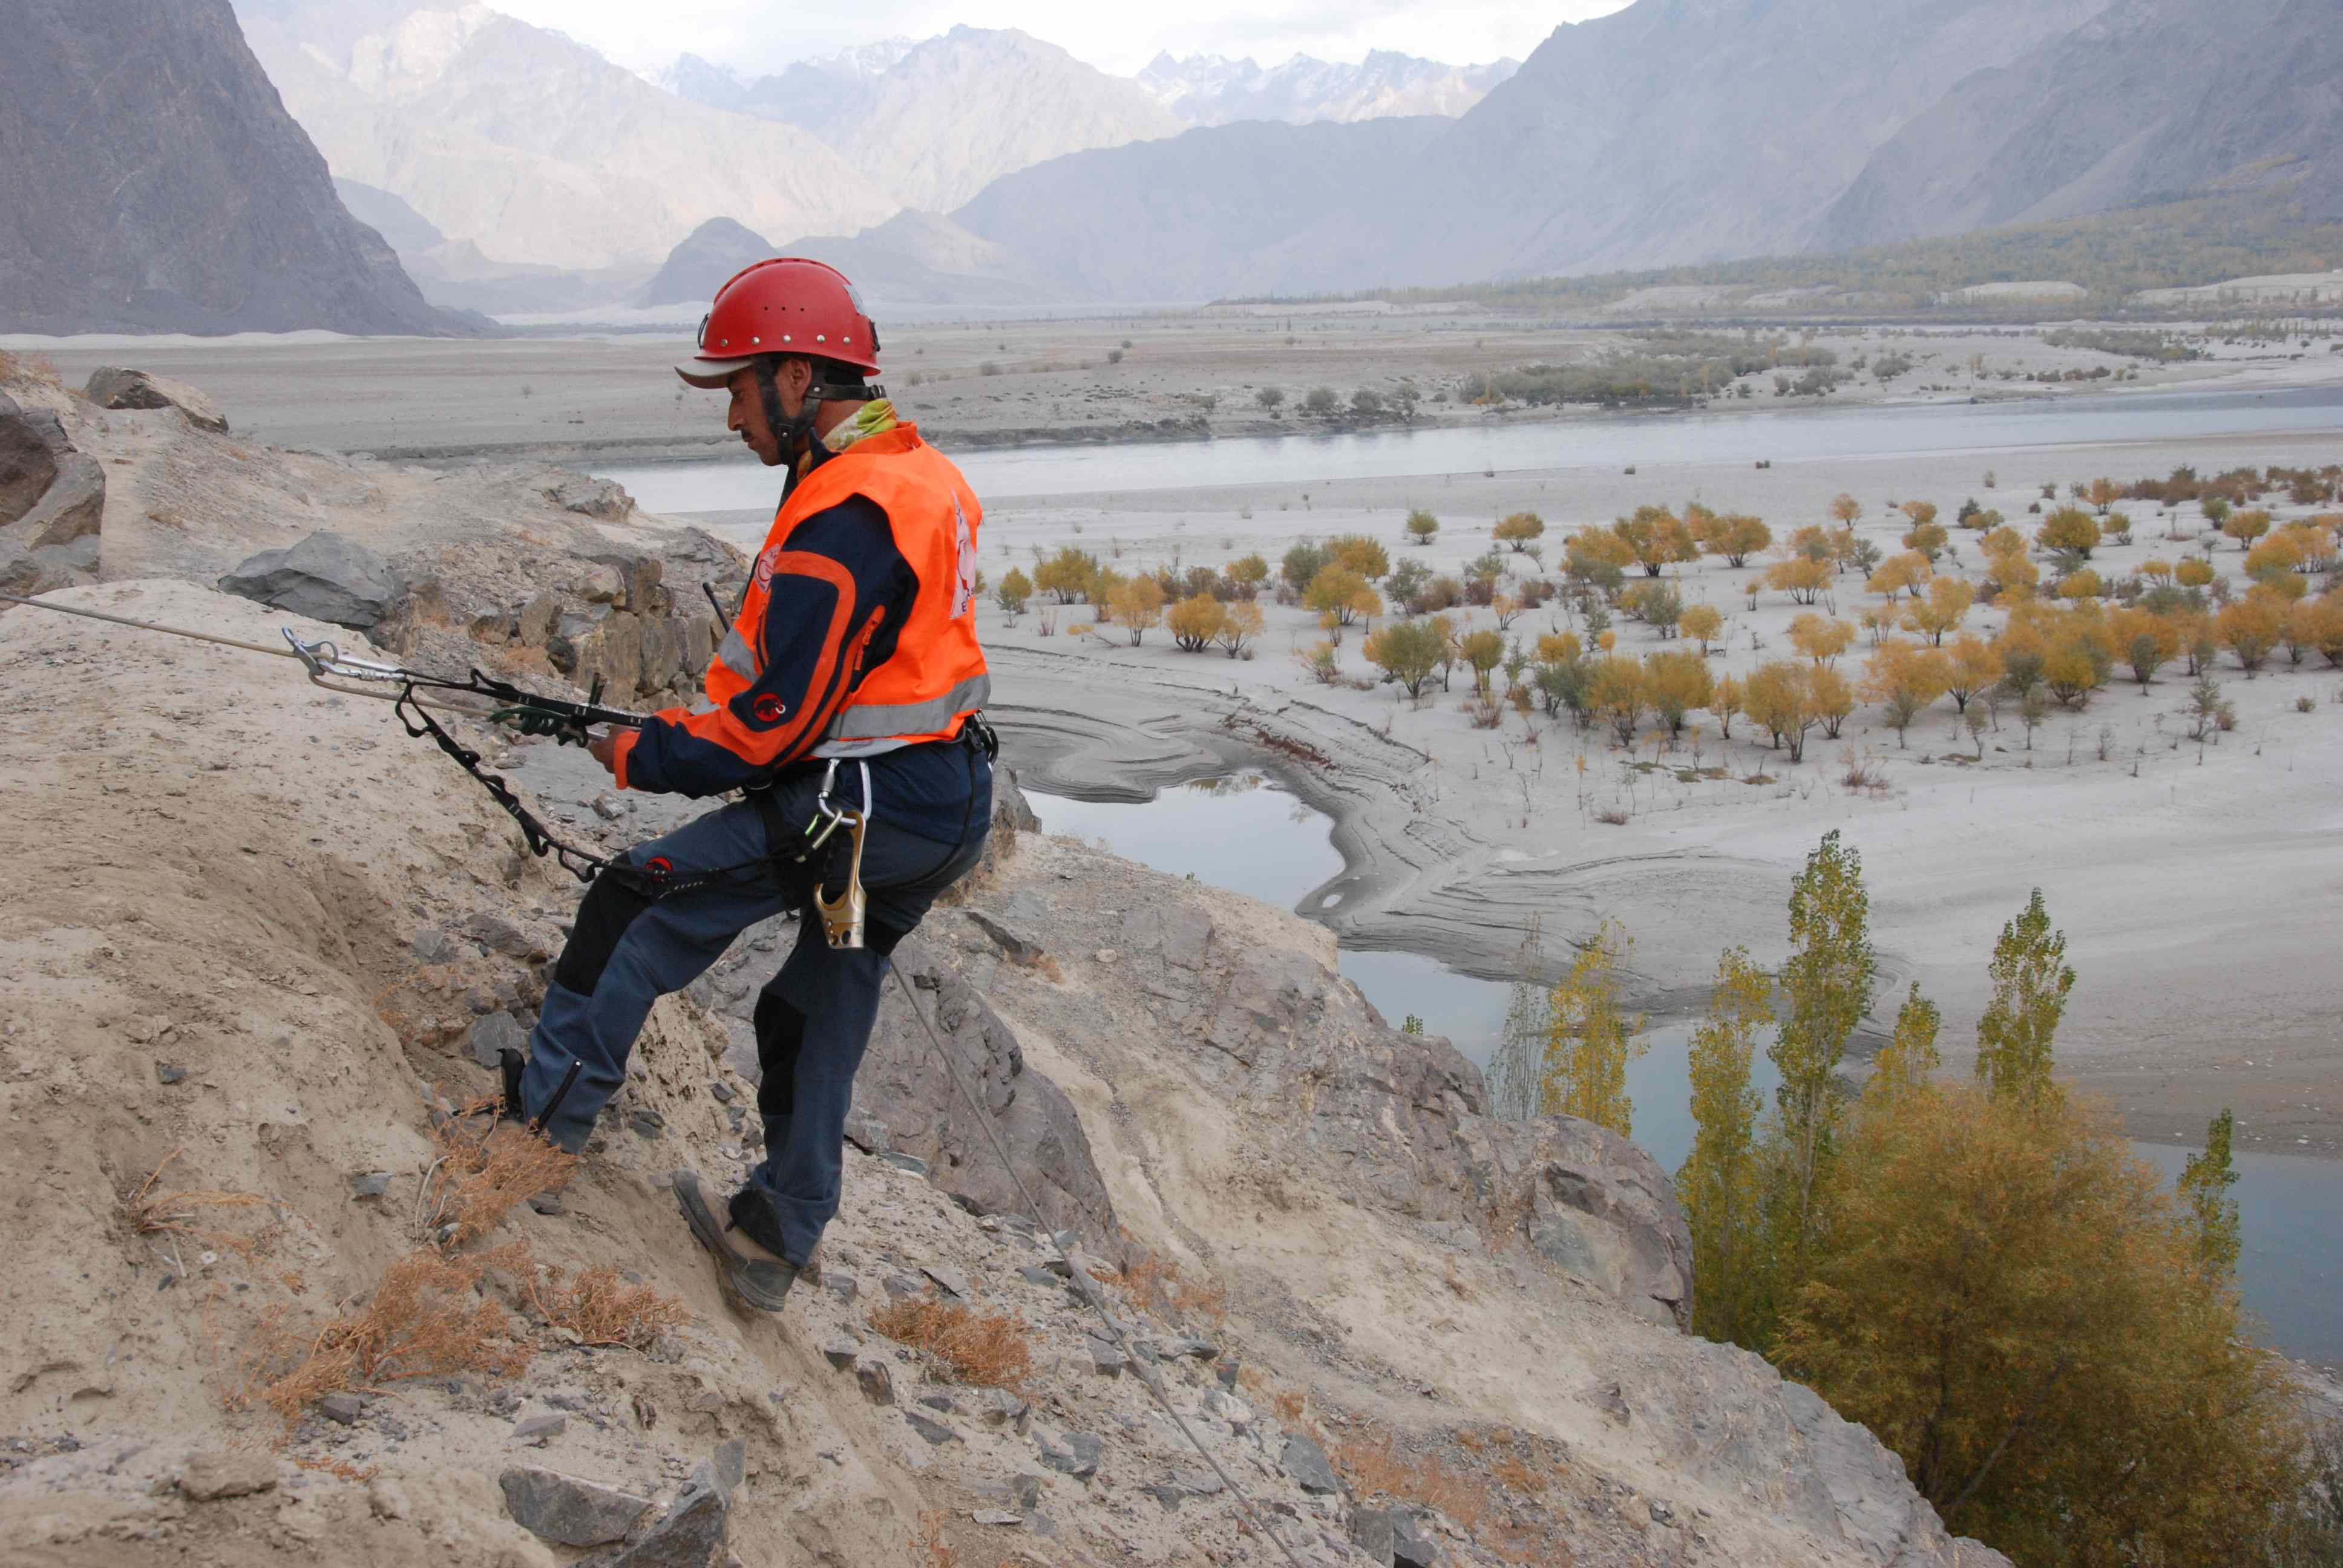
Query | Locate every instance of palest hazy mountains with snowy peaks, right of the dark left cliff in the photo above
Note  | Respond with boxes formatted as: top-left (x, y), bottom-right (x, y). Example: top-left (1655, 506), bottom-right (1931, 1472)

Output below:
top-left (237, 0), bottom-right (1511, 281)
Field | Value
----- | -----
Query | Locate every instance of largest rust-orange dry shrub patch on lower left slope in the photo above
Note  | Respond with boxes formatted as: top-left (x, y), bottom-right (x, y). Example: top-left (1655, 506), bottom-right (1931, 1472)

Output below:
top-left (229, 1247), bottom-right (529, 1429)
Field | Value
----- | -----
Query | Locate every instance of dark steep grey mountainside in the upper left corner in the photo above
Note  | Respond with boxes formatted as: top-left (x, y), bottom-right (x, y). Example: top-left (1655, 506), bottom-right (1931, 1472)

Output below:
top-left (0, 0), bottom-right (471, 335)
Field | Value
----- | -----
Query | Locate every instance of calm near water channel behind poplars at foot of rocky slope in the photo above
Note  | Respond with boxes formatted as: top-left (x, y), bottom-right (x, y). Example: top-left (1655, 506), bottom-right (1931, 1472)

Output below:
top-left (1026, 774), bottom-right (2343, 1367)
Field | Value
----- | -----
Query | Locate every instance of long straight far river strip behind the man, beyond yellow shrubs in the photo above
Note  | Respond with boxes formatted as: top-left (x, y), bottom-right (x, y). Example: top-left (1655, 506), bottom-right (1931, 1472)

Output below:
top-left (595, 384), bottom-right (2343, 514)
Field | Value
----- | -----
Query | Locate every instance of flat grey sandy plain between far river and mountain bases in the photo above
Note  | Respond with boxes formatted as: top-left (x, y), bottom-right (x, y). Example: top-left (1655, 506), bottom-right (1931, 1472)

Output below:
top-left (0, 312), bottom-right (2343, 462)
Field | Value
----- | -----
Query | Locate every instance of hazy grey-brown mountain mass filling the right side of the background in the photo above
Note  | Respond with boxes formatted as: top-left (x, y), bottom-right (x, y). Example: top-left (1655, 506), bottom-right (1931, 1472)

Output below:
top-left (899, 0), bottom-right (2343, 300)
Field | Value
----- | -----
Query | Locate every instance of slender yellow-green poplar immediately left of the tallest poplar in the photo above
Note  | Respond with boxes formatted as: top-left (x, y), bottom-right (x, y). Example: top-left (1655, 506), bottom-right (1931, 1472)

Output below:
top-left (1675, 947), bottom-right (1774, 1345)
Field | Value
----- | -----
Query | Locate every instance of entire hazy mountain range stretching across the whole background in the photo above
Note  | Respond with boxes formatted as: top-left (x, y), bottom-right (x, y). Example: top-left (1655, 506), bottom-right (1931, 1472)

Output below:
top-left (18, 0), bottom-right (2343, 333)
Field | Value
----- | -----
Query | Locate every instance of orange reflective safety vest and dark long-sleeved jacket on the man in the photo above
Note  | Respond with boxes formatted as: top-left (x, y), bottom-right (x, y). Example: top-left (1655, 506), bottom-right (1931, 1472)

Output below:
top-left (614, 424), bottom-right (991, 794)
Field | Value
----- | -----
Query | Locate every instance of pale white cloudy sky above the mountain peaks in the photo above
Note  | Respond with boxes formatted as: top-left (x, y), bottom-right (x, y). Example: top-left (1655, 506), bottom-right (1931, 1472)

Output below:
top-left (490, 0), bottom-right (1626, 75)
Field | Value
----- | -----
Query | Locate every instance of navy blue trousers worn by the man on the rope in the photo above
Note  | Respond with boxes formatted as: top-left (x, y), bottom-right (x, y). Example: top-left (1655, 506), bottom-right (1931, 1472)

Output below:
top-left (520, 755), bottom-right (989, 1263)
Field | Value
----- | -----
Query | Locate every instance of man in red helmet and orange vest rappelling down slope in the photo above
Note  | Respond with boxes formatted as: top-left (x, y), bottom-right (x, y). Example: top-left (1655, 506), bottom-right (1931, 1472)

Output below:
top-left (503, 258), bottom-right (991, 1310)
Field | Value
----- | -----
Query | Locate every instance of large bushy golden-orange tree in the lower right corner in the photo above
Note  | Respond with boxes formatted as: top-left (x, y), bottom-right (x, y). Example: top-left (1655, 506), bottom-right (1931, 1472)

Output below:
top-left (1776, 1085), bottom-right (2317, 1568)
